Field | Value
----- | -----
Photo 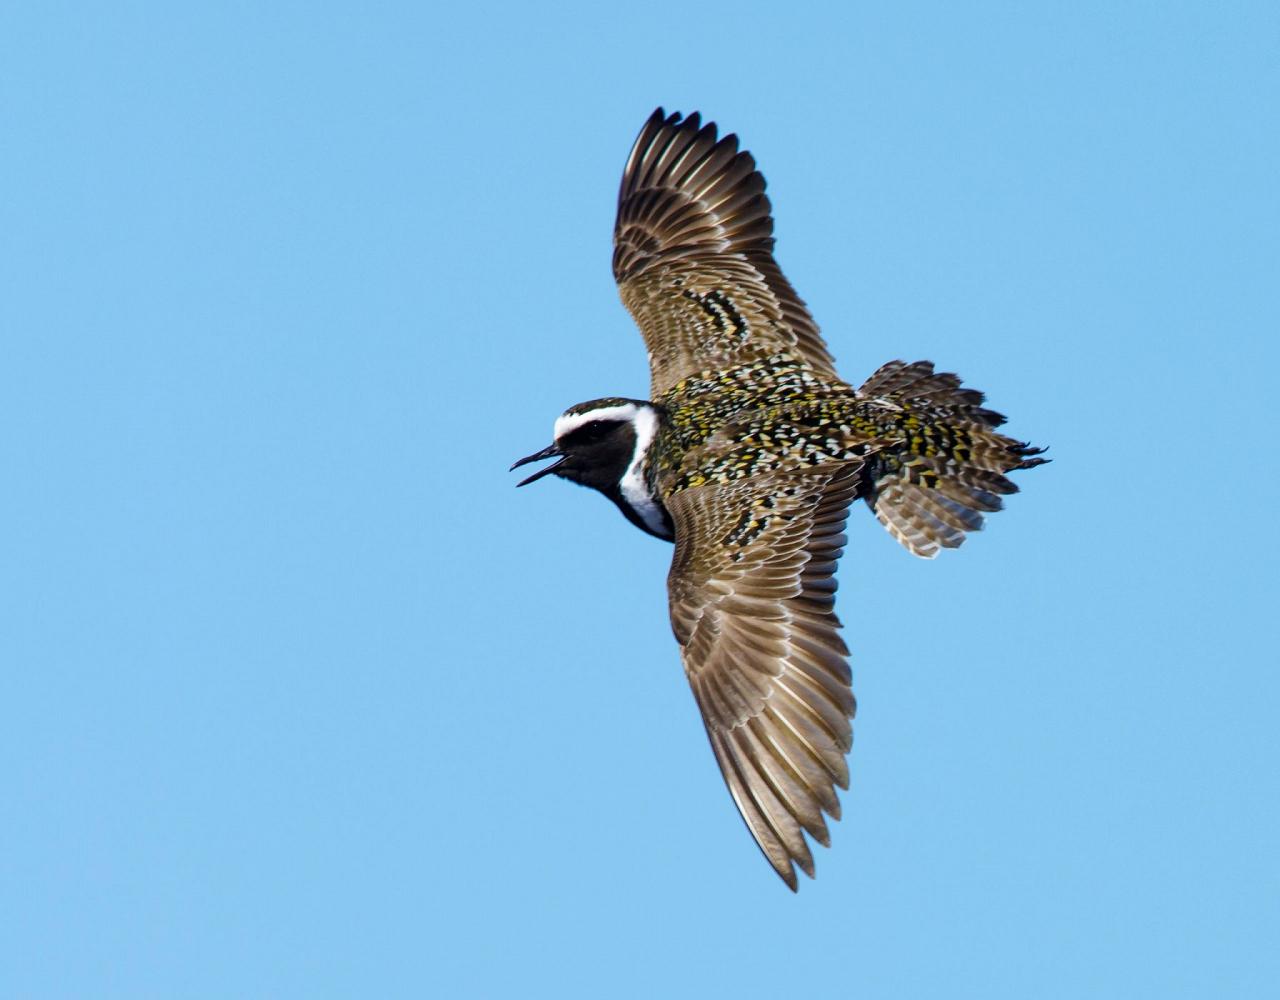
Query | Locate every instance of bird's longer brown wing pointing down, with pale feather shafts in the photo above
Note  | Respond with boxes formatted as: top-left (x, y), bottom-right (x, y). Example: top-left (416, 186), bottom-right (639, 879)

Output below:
top-left (667, 466), bottom-right (859, 890)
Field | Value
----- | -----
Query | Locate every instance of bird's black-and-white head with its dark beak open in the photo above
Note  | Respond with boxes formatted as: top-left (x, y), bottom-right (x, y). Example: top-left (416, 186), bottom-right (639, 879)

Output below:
top-left (511, 397), bottom-right (658, 493)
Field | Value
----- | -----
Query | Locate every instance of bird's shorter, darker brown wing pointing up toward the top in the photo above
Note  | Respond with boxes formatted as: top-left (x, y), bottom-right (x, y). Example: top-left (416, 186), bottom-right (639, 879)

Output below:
top-left (613, 108), bottom-right (836, 398)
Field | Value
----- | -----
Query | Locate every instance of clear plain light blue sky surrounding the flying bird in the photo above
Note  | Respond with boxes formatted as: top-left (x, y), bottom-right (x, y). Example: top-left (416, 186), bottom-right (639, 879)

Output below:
top-left (0, 3), bottom-right (1280, 1000)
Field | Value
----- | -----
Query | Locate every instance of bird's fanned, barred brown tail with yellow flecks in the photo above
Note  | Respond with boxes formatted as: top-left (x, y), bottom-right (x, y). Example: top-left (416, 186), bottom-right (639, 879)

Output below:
top-left (860, 361), bottom-right (1048, 560)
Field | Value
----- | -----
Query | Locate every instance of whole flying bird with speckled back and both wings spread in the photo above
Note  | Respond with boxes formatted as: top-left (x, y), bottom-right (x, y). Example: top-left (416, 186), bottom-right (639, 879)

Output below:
top-left (512, 108), bottom-right (1048, 891)
